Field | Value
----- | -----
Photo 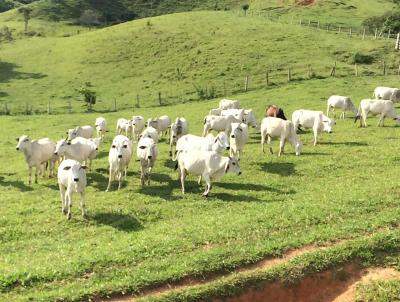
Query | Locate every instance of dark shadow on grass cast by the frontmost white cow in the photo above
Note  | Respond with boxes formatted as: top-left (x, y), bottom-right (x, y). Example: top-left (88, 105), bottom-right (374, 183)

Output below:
top-left (88, 212), bottom-right (143, 232)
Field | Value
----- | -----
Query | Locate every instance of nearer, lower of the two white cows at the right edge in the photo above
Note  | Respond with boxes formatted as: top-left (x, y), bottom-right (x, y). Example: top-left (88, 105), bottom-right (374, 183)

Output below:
top-left (355, 99), bottom-right (400, 127)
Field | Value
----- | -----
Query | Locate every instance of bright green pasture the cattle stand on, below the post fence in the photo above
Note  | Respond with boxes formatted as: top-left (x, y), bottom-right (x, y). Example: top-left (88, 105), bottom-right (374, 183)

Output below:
top-left (0, 76), bottom-right (400, 301)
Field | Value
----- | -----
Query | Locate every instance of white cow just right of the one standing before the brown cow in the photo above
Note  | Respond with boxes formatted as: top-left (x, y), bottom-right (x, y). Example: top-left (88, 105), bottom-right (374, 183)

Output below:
top-left (292, 109), bottom-right (336, 146)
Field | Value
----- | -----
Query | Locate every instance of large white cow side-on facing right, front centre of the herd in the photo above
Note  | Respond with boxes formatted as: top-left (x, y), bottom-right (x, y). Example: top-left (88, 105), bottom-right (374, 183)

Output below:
top-left (176, 150), bottom-right (241, 196)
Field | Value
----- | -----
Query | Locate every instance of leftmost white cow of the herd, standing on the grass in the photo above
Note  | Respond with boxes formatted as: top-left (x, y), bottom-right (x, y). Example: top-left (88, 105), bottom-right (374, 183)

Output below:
top-left (16, 135), bottom-right (58, 184)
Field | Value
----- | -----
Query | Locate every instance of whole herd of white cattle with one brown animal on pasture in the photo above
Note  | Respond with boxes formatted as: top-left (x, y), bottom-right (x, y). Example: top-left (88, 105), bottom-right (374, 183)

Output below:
top-left (16, 87), bottom-right (400, 219)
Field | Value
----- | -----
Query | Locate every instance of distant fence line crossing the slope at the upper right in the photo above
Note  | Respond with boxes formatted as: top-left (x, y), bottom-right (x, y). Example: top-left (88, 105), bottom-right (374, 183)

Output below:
top-left (230, 10), bottom-right (398, 40)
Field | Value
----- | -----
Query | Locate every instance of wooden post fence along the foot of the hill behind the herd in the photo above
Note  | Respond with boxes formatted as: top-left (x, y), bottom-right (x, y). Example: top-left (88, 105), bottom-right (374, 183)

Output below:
top-left (0, 61), bottom-right (400, 115)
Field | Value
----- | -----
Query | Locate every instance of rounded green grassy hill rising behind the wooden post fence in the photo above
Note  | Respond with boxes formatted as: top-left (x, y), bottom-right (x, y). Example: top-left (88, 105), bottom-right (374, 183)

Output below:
top-left (0, 12), bottom-right (398, 112)
